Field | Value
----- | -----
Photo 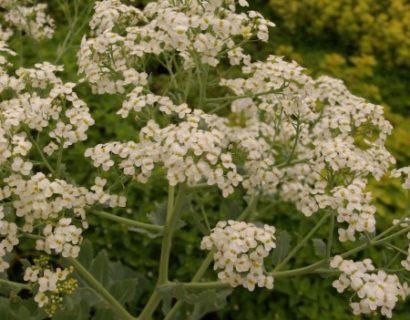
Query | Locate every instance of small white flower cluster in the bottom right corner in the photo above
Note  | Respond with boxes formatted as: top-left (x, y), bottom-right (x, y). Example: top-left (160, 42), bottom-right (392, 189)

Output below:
top-left (330, 256), bottom-right (410, 318)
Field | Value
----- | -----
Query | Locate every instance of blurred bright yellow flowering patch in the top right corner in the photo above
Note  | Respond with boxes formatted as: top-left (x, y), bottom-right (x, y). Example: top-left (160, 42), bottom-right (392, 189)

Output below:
top-left (270, 0), bottom-right (410, 66)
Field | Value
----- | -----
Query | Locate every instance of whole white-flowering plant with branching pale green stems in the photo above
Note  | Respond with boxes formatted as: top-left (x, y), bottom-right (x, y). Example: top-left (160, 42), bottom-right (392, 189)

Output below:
top-left (0, 0), bottom-right (410, 320)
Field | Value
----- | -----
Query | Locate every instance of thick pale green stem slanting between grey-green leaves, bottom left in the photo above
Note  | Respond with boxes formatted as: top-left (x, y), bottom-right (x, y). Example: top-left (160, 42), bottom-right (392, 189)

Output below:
top-left (67, 258), bottom-right (136, 320)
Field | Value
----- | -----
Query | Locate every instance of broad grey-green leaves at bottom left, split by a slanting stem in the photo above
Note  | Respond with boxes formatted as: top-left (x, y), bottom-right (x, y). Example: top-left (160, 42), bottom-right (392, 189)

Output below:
top-left (0, 240), bottom-right (147, 320)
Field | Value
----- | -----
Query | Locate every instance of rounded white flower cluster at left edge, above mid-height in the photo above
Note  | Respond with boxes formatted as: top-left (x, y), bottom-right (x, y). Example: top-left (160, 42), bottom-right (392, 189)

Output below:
top-left (0, 62), bottom-right (94, 164)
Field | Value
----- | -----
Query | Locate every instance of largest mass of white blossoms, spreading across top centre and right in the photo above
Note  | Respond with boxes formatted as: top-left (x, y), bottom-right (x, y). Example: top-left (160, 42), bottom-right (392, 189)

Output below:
top-left (78, 0), bottom-right (395, 250)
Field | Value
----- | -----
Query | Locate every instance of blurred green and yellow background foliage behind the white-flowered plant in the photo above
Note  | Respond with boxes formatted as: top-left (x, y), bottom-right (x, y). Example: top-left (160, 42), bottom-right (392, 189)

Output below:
top-left (4, 0), bottom-right (410, 320)
